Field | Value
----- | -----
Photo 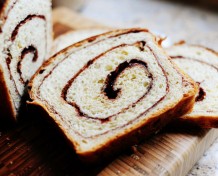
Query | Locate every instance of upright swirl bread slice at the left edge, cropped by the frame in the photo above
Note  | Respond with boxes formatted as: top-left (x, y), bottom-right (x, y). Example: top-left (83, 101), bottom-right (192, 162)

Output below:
top-left (0, 0), bottom-right (52, 119)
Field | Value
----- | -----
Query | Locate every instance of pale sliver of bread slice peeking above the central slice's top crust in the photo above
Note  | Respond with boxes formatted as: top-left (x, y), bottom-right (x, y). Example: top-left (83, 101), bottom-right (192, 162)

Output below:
top-left (51, 29), bottom-right (106, 55)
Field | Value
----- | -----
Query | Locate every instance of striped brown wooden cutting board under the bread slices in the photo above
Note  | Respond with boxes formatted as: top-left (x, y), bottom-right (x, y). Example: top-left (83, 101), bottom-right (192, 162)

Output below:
top-left (0, 8), bottom-right (218, 176)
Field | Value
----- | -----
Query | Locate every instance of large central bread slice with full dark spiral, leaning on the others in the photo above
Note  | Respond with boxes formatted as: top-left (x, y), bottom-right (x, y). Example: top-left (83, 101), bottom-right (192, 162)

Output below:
top-left (28, 29), bottom-right (197, 162)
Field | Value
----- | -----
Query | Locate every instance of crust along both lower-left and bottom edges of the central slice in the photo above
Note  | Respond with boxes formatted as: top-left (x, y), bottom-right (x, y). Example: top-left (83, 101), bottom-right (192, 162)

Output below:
top-left (28, 84), bottom-right (195, 164)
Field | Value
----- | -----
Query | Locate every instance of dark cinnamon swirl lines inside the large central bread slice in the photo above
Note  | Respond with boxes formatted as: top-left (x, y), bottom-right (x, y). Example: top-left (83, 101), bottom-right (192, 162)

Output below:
top-left (38, 30), bottom-right (169, 138)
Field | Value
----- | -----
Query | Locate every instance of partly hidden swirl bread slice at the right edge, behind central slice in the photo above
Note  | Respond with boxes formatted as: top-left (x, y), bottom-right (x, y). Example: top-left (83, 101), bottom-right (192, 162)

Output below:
top-left (167, 44), bottom-right (218, 128)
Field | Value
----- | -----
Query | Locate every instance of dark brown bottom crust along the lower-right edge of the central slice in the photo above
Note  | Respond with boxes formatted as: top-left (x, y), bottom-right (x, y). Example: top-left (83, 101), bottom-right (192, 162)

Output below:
top-left (79, 93), bottom-right (194, 163)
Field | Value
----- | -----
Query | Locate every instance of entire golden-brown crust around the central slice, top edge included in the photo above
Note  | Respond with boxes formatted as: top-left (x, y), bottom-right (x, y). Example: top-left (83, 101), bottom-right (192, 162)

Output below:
top-left (29, 29), bottom-right (197, 163)
